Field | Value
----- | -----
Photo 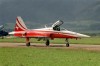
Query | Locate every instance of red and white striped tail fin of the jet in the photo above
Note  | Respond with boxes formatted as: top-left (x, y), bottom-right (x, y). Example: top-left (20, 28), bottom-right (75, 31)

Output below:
top-left (15, 16), bottom-right (27, 31)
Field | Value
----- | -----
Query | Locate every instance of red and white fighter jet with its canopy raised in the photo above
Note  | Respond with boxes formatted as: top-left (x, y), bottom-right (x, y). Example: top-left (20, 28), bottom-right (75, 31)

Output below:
top-left (9, 16), bottom-right (90, 47)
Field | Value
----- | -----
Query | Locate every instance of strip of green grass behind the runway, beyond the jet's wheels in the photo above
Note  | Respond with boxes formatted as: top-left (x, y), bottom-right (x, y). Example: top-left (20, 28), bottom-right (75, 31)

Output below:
top-left (0, 37), bottom-right (100, 44)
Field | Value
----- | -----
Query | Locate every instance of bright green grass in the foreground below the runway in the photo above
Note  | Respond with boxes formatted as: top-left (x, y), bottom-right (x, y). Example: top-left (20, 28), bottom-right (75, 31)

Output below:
top-left (0, 47), bottom-right (100, 66)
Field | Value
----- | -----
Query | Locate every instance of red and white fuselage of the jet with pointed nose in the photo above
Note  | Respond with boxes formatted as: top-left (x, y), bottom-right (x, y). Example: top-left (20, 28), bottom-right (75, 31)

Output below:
top-left (11, 27), bottom-right (89, 38)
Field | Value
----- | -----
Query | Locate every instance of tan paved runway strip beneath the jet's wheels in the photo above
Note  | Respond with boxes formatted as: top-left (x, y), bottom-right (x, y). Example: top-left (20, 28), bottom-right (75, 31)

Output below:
top-left (0, 43), bottom-right (100, 51)
